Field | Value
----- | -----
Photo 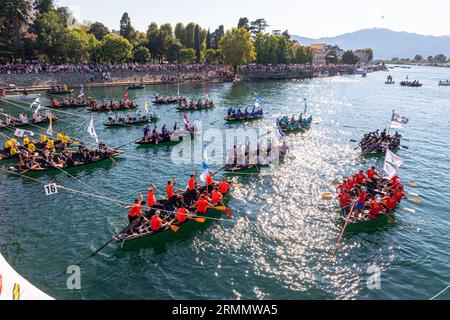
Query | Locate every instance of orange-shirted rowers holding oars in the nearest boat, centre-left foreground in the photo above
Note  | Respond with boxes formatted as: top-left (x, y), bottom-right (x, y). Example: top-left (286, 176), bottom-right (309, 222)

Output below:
top-left (128, 172), bottom-right (231, 235)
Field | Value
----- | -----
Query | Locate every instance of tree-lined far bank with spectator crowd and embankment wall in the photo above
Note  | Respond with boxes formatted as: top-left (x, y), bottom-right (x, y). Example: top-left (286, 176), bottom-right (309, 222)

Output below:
top-left (0, 0), bottom-right (385, 93)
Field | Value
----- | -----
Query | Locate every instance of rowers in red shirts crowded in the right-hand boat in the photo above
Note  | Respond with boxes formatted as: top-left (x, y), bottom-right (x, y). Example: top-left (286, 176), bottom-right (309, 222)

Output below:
top-left (336, 167), bottom-right (405, 222)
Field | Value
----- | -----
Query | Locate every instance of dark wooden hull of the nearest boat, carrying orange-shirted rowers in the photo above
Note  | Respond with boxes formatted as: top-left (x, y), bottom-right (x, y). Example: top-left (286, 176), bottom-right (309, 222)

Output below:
top-left (114, 181), bottom-right (233, 249)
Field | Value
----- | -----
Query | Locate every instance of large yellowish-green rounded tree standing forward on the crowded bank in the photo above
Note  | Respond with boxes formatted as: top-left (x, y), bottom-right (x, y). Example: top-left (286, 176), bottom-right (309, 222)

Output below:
top-left (219, 28), bottom-right (256, 73)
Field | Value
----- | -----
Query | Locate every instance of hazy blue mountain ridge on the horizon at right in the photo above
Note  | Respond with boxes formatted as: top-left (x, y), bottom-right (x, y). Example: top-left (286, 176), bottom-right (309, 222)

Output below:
top-left (291, 28), bottom-right (450, 59)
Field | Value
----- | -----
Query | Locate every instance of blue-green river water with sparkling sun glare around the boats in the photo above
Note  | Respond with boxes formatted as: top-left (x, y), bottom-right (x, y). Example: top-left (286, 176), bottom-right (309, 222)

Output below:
top-left (0, 67), bottom-right (450, 299)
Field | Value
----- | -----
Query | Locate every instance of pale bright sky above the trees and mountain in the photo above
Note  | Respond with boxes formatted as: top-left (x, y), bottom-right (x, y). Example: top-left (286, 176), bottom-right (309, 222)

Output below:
top-left (56, 0), bottom-right (450, 38)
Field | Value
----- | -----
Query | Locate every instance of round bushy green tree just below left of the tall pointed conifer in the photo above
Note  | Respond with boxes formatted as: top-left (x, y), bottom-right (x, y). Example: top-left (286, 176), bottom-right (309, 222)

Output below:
top-left (101, 33), bottom-right (133, 63)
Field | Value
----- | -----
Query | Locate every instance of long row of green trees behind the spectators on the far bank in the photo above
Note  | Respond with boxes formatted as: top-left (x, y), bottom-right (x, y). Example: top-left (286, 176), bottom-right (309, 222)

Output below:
top-left (0, 0), bottom-right (360, 68)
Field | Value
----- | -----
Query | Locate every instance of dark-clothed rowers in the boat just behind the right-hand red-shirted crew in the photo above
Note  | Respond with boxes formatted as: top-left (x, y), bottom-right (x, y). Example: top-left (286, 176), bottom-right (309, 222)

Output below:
top-left (359, 129), bottom-right (402, 154)
